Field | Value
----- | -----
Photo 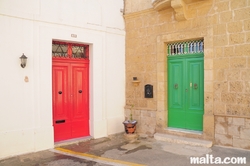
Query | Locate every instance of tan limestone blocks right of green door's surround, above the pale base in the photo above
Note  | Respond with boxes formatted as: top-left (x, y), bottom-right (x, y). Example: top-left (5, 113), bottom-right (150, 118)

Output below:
top-left (213, 0), bottom-right (250, 117)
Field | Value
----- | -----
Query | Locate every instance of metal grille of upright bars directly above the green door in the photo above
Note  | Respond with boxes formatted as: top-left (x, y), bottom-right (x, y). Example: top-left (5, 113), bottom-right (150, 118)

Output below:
top-left (168, 40), bottom-right (204, 56)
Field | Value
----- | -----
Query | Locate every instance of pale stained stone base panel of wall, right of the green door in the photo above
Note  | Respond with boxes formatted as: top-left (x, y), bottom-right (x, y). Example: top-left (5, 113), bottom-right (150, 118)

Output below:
top-left (215, 116), bottom-right (250, 149)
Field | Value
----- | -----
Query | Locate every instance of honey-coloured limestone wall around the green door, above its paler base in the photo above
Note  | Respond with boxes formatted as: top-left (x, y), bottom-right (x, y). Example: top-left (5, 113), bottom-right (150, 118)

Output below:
top-left (124, 0), bottom-right (250, 147)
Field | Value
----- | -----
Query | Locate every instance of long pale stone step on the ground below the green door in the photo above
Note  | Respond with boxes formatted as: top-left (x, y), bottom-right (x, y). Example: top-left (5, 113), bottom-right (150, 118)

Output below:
top-left (154, 133), bottom-right (213, 148)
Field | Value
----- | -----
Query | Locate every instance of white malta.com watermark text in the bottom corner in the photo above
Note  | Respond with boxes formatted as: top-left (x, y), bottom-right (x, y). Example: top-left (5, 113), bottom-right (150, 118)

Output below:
top-left (190, 154), bottom-right (246, 164)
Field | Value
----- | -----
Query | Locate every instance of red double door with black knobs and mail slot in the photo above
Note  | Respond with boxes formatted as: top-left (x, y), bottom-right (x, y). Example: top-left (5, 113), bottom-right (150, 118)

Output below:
top-left (52, 41), bottom-right (89, 142)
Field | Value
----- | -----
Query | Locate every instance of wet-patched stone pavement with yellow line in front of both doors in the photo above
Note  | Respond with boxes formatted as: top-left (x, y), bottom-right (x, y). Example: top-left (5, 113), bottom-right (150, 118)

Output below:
top-left (0, 134), bottom-right (250, 166)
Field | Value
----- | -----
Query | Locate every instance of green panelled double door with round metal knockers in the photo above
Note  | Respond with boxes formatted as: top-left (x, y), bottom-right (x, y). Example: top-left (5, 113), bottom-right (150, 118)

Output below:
top-left (168, 54), bottom-right (204, 131)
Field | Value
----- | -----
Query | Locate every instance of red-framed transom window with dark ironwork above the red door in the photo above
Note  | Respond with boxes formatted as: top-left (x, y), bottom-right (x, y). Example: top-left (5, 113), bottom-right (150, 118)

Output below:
top-left (52, 41), bottom-right (89, 59)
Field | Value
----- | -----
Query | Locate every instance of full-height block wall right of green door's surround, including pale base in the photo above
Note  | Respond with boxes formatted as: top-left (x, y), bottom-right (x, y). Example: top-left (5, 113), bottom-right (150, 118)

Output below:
top-left (213, 0), bottom-right (250, 149)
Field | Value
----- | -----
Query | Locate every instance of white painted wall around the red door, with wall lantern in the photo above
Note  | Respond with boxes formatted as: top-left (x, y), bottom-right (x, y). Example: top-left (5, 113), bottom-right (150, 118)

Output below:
top-left (0, 0), bottom-right (125, 158)
